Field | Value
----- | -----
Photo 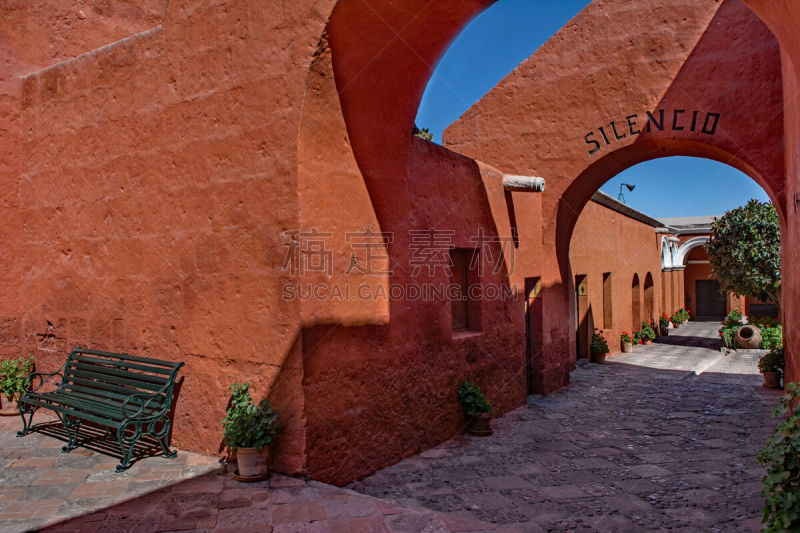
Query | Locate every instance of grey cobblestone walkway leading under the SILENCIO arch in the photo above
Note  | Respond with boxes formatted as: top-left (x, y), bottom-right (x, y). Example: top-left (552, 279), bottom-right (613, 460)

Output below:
top-left (350, 322), bottom-right (781, 532)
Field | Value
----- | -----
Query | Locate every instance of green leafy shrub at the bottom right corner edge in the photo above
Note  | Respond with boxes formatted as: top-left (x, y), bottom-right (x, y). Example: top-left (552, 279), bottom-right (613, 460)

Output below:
top-left (758, 383), bottom-right (800, 533)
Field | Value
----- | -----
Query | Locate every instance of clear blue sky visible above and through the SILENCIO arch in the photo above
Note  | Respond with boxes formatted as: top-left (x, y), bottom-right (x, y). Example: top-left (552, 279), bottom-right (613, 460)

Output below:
top-left (416, 0), bottom-right (767, 218)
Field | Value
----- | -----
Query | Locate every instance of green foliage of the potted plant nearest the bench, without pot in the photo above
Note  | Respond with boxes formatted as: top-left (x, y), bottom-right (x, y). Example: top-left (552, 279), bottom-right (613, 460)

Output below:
top-left (222, 383), bottom-right (279, 450)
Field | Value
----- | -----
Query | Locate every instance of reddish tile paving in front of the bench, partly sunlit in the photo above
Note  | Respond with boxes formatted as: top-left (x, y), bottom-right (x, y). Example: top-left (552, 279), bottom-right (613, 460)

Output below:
top-left (0, 410), bottom-right (494, 533)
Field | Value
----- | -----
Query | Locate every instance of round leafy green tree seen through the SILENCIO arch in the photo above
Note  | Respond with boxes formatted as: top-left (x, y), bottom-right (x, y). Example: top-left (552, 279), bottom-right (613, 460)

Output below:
top-left (705, 200), bottom-right (781, 309)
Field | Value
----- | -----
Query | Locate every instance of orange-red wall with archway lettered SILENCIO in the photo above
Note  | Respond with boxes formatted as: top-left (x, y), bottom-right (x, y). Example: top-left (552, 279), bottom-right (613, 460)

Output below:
top-left (444, 0), bottom-right (785, 392)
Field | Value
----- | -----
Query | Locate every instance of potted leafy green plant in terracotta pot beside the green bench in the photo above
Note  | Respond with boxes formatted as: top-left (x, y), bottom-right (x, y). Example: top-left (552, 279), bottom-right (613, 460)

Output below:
top-left (222, 383), bottom-right (278, 481)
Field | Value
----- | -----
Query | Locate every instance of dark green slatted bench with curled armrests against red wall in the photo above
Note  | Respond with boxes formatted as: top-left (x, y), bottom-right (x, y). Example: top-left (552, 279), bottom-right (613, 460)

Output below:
top-left (17, 347), bottom-right (183, 472)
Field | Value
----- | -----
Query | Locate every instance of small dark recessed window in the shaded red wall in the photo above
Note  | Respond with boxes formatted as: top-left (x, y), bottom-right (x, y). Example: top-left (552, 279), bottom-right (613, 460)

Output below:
top-left (450, 248), bottom-right (481, 331)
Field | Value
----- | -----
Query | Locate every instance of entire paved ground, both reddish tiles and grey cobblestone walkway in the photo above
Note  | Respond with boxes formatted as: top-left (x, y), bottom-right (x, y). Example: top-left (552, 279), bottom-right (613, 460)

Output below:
top-left (0, 323), bottom-right (780, 533)
